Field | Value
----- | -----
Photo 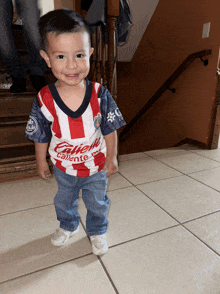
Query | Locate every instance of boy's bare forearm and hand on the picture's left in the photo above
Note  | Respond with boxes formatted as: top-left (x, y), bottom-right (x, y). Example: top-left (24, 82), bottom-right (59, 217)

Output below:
top-left (34, 142), bottom-right (51, 180)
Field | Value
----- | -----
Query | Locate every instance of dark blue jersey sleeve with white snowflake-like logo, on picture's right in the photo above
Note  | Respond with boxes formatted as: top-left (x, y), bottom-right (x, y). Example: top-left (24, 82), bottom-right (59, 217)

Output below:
top-left (99, 86), bottom-right (126, 136)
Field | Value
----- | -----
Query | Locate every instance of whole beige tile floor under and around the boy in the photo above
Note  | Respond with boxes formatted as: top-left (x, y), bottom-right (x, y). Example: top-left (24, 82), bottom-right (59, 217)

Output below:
top-left (0, 145), bottom-right (220, 294)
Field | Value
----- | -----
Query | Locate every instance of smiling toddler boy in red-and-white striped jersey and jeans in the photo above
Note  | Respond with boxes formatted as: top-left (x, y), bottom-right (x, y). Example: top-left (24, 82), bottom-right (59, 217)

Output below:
top-left (25, 9), bottom-right (125, 255)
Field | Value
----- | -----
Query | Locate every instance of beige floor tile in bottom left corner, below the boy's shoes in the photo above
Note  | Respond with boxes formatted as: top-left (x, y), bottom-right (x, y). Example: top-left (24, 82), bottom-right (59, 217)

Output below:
top-left (0, 255), bottom-right (115, 294)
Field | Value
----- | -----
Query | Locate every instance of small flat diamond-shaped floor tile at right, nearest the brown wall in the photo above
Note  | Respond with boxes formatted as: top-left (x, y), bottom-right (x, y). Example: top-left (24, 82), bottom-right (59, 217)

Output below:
top-left (156, 151), bottom-right (220, 174)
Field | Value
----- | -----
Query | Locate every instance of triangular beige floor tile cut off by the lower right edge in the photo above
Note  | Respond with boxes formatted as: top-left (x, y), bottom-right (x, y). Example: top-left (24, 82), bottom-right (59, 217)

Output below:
top-left (184, 212), bottom-right (220, 254)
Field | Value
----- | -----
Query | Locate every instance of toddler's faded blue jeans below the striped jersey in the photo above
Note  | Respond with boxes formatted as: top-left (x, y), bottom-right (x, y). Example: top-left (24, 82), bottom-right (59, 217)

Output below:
top-left (53, 166), bottom-right (110, 236)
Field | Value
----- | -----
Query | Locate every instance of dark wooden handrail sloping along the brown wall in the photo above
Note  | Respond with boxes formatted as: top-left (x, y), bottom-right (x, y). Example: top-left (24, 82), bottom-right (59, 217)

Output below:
top-left (119, 49), bottom-right (212, 143)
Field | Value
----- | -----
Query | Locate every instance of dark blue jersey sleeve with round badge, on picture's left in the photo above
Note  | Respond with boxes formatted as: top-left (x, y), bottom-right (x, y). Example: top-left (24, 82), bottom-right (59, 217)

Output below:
top-left (25, 97), bottom-right (52, 143)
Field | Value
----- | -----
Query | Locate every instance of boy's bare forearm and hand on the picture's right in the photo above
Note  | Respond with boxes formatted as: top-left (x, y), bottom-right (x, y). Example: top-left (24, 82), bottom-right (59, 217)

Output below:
top-left (101, 131), bottom-right (118, 178)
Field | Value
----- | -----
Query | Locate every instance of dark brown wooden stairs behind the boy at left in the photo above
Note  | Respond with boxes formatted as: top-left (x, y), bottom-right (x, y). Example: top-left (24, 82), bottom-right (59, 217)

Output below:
top-left (0, 26), bottom-right (55, 182)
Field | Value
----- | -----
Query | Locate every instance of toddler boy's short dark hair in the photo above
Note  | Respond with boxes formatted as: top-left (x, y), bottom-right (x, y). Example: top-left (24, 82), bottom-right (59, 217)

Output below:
top-left (39, 8), bottom-right (91, 50)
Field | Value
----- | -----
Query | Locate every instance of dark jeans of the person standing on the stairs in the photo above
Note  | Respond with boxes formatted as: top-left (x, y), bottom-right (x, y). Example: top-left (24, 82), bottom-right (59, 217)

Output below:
top-left (0, 0), bottom-right (46, 78)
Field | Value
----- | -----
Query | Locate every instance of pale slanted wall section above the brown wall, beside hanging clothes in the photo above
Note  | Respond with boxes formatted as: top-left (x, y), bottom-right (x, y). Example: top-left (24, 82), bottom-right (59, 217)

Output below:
top-left (118, 0), bottom-right (160, 61)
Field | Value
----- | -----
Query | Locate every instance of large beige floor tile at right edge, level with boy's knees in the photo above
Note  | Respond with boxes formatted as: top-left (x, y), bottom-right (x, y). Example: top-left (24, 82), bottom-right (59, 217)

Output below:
top-left (138, 176), bottom-right (220, 222)
